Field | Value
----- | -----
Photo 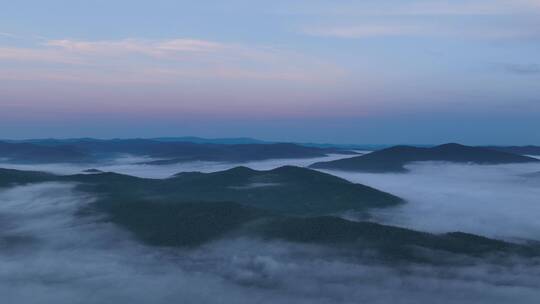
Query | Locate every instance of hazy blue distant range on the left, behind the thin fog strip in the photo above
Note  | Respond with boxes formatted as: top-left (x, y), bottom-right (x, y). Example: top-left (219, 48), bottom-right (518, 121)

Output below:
top-left (0, 138), bottom-right (354, 165)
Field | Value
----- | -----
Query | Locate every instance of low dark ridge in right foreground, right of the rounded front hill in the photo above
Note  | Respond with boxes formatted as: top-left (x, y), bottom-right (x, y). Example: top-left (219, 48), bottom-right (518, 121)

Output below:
top-left (254, 216), bottom-right (540, 261)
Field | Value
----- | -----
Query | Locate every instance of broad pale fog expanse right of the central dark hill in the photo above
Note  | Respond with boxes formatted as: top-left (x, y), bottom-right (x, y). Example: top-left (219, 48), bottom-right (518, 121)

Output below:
top-left (325, 163), bottom-right (540, 240)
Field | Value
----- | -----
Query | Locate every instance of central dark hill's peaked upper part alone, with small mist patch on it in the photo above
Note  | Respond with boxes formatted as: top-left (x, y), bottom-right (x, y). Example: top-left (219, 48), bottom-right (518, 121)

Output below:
top-left (162, 166), bottom-right (402, 215)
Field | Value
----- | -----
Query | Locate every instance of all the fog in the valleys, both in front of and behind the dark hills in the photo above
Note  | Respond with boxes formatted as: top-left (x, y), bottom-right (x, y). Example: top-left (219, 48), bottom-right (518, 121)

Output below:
top-left (0, 155), bottom-right (540, 304)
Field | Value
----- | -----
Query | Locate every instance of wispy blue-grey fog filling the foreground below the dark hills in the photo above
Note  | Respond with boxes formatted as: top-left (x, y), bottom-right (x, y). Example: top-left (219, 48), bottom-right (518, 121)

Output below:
top-left (0, 183), bottom-right (540, 304)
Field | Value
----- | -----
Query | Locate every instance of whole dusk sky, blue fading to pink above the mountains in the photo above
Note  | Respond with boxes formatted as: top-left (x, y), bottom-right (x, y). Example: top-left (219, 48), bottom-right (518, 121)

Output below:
top-left (0, 0), bottom-right (540, 145)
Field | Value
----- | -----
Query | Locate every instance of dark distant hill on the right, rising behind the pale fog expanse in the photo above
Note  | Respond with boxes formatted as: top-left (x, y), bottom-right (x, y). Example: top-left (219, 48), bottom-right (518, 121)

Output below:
top-left (310, 144), bottom-right (538, 172)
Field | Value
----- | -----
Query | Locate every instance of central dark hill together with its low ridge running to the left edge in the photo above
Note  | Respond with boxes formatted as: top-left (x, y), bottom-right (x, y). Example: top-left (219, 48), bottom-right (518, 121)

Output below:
top-left (0, 166), bottom-right (403, 215)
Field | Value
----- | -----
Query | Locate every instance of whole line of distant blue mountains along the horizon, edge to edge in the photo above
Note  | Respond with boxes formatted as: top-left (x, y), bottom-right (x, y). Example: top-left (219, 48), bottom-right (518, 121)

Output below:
top-left (0, 137), bottom-right (540, 172)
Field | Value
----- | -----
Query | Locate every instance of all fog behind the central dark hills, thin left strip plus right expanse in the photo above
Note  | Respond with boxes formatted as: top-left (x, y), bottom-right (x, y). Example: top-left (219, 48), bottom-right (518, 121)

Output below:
top-left (0, 155), bottom-right (540, 240)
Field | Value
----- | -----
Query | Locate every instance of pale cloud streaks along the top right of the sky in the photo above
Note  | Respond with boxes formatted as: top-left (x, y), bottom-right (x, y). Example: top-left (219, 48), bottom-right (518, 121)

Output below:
top-left (297, 0), bottom-right (540, 42)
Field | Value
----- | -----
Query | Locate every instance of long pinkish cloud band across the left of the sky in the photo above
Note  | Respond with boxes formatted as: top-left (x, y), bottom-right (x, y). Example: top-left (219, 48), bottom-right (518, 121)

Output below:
top-left (0, 38), bottom-right (345, 86)
